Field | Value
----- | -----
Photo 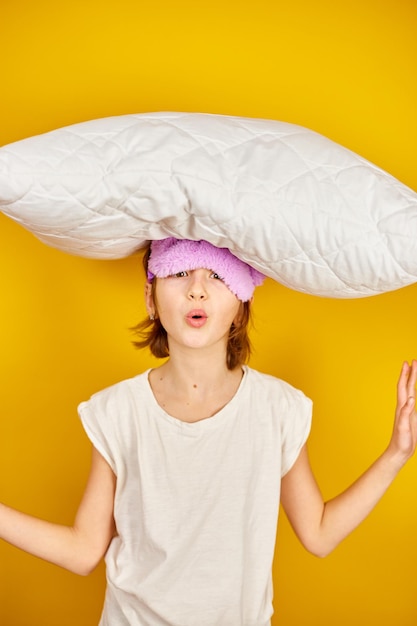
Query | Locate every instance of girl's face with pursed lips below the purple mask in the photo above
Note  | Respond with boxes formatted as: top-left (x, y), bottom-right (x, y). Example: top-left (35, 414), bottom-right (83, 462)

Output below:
top-left (146, 269), bottom-right (241, 352)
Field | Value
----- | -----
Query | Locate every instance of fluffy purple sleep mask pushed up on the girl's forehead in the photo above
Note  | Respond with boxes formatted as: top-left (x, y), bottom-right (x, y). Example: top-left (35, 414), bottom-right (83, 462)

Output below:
top-left (148, 237), bottom-right (265, 302)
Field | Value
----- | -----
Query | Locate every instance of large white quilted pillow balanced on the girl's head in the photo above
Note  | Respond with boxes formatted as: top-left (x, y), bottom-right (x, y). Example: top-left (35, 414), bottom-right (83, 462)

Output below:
top-left (0, 113), bottom-right (417, 298)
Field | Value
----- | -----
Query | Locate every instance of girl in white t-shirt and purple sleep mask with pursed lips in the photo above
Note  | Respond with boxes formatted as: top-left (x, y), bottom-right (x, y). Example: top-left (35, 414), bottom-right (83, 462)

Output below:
top-left (0, 238), bottom-right (417, 626)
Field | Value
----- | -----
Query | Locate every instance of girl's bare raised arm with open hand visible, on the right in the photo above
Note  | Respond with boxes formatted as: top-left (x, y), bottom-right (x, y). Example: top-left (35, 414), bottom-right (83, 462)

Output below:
top-left (281, 361), bottom-right (417, 556)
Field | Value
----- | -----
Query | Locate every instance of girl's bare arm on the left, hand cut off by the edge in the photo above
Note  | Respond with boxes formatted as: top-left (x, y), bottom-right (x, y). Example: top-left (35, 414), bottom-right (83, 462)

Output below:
top-left (0, 448), bottom-right (116, 575)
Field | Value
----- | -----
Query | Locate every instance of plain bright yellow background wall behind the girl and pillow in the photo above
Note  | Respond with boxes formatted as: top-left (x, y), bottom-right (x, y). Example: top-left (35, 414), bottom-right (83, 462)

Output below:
top-left (0, 0), bottom-right (417, 626)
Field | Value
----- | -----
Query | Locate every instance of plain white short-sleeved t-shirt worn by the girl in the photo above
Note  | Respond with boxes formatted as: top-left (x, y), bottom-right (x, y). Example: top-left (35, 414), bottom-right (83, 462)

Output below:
top-left (79, 366), bottom-right (311, 626)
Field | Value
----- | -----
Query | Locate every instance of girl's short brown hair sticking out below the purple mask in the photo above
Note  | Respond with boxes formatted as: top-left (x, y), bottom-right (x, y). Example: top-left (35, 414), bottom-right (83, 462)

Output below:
top-left (132, 244), bottom-right (251, 370)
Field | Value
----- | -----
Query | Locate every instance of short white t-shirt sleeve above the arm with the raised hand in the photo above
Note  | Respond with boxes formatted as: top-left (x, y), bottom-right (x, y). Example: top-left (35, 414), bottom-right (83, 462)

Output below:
top-left (281, 388), bottom-right (313, 476)
